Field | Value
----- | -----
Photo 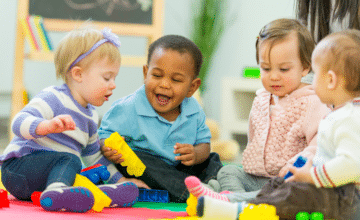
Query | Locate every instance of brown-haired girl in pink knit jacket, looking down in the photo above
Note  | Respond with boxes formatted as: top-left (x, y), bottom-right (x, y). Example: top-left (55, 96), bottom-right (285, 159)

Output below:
top-left (185, 19), bottom-right (330, 205)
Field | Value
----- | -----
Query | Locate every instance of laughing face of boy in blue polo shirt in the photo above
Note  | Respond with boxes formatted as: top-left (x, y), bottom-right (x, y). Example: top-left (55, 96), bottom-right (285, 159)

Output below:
top-left (143, 47), bottom-right (201, 121)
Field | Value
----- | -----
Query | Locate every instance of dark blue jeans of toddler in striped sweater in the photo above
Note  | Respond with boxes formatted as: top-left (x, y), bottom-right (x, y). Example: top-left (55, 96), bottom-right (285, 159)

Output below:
top-left (1, 151), bottom-right (82, 200)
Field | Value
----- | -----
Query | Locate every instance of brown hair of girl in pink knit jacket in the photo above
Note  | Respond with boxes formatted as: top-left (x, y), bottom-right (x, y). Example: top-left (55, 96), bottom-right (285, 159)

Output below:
top-left (255, 18), bottom-right (315, 71)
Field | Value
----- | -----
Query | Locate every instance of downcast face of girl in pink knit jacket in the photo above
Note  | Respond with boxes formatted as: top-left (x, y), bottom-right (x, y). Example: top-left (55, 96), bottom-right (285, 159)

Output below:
top-left (259, 32), bottom-right (310, 99)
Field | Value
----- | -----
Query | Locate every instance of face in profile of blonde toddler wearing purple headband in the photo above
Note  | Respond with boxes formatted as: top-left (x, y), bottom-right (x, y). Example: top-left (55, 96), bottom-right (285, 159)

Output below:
top-left (72, 58), bottom-right (120, 107)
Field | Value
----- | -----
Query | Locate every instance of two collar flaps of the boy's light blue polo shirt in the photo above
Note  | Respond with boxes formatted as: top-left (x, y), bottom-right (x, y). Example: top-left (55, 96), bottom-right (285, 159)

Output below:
top-left (135, 85), bottom-right (200, 117)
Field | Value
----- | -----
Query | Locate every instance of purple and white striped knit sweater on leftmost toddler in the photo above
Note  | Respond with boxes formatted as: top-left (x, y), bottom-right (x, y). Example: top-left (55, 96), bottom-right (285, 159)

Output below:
top-left (0, 84), bottom-right (122, 183)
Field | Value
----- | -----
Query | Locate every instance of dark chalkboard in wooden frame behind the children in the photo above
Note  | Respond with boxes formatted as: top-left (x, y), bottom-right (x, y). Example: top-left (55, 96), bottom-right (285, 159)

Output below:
top-left (29, 0), bottom-right (154, 25)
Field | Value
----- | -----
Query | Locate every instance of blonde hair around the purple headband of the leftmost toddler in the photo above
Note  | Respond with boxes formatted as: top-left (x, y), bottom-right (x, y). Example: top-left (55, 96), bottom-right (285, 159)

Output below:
top-left (54, 22), bottom-right (121, 82)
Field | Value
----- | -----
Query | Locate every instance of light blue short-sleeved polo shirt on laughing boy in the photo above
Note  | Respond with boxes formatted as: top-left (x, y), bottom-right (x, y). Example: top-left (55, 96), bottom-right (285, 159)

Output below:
top-left (98, 85), bottom-right (211, 165)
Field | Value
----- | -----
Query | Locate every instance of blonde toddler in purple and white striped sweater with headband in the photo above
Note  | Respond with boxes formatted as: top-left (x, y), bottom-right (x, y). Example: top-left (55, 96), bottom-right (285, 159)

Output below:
top-left (0, 24), bottom-right (139, 212)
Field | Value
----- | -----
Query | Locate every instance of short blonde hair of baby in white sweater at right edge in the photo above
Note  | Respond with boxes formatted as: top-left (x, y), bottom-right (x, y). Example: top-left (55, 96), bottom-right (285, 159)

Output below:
top-left (319, 29), bottom-right (360, 93)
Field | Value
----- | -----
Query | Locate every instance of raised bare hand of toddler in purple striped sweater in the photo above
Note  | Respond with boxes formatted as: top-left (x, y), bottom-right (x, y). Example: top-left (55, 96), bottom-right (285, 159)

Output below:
top-left (35, 115), bottom-right (76, 135)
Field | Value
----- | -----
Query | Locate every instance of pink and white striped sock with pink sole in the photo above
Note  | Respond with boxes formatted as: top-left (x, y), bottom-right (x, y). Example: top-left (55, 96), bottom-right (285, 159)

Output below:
top-left (185, 176), bottom-right (229, 201)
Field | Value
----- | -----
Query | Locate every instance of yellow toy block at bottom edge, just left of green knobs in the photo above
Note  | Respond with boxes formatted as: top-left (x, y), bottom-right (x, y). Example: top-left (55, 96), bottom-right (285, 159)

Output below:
top-left (239, 204), bottom-right (279, 220)
